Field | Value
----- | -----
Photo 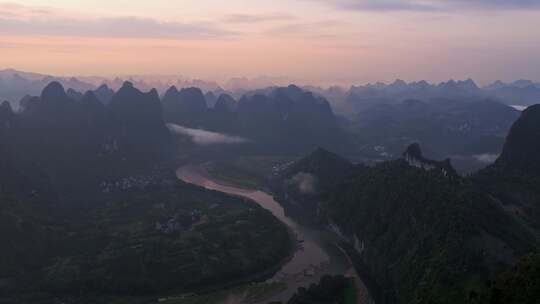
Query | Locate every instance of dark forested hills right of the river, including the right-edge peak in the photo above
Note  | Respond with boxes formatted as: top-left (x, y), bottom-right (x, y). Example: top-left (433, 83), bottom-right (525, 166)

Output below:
top-left (274, 106), bottom-right (540, 303)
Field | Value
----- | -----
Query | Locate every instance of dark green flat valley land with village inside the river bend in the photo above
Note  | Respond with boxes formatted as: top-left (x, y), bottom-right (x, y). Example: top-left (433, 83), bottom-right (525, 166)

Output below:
top-left (0, 181), bottom-right (291, 299)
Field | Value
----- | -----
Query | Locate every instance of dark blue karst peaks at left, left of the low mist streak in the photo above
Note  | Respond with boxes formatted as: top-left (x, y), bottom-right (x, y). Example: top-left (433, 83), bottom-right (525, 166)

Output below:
top-left (2, 82), bottom-right (171, 200)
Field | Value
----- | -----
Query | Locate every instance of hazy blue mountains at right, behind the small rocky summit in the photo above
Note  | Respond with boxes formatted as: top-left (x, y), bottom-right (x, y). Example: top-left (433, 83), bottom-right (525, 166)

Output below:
top-left (347, 97), bottom-right (519, 167)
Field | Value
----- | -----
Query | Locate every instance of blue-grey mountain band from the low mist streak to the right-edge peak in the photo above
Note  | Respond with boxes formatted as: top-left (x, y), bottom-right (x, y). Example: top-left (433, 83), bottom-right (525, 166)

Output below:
top-left (158, 85), bottom-right (519, 167)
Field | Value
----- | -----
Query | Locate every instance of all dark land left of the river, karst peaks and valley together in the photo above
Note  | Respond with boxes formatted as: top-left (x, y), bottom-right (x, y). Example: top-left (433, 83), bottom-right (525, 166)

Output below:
top-left (0, 82), bottom-right (291, 303)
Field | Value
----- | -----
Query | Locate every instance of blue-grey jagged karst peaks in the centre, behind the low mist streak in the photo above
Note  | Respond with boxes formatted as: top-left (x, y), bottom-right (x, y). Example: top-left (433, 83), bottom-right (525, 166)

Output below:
top-left (163, 85), bottom-right (351, 154)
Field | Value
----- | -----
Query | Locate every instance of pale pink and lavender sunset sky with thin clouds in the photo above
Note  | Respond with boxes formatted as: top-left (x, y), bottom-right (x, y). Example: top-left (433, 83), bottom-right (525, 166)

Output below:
top-left (0, 0), bottom-right (540, 85)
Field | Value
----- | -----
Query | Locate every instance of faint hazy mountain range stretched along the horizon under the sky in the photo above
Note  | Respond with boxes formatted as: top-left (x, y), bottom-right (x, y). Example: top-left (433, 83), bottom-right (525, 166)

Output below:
top-left (0, 69), bottom-right (540, 113)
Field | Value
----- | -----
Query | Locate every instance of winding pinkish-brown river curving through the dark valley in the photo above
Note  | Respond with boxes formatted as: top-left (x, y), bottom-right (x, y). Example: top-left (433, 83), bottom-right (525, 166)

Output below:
top-left (176, 165), bottom-right (368, 303)
